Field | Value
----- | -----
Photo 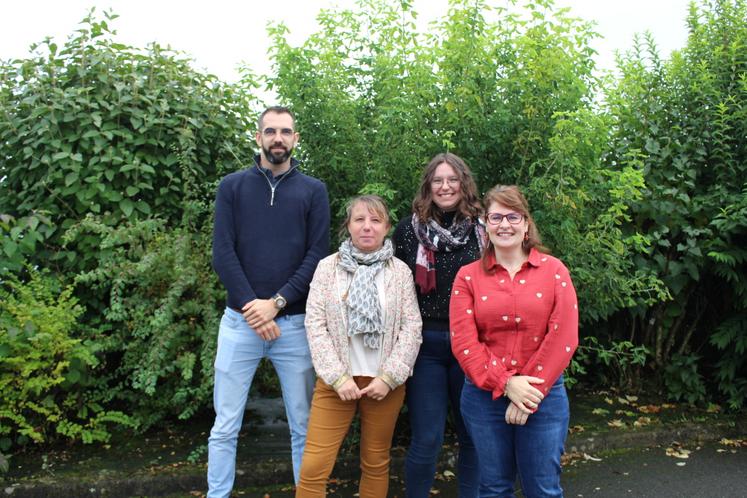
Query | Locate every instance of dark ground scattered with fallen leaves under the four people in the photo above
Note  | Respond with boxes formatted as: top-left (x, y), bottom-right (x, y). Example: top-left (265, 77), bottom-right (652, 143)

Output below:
top-left (0, 392), bottom-right (747, 498)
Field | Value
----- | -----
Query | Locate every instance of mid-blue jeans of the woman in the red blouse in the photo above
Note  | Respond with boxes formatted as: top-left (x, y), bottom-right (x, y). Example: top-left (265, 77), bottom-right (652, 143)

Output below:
top-left (462, 376), bottom-right (569, 498)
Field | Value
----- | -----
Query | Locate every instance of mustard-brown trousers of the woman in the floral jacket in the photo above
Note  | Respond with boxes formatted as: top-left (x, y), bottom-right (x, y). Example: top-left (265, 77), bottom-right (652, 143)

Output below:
top-left (296, 377), bottom-right (405, 498)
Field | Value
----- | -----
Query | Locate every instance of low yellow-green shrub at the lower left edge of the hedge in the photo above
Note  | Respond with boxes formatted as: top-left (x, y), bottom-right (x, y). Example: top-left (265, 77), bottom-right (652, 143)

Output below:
top-left (0, 270), bottom-right (133, 451)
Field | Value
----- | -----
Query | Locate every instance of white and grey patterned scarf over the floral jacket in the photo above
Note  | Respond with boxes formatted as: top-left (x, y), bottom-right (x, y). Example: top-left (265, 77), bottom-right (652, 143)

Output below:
top-left (338, 238), bottom-right (394, 349)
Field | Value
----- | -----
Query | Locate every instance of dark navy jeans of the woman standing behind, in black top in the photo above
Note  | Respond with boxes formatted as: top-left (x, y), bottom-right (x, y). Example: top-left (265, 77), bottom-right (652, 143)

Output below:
top-left (405, 330), bottom-right (479, 498)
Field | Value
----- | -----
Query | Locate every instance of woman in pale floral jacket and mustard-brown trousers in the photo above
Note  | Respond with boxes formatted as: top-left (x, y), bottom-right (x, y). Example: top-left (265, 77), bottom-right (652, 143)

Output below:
top-left (296, 195), bottom-right (422, 498)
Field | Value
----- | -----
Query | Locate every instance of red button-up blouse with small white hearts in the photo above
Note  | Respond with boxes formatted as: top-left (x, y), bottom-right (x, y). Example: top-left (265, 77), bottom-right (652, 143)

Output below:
top-left (449, 249), bottom-right (578, 399)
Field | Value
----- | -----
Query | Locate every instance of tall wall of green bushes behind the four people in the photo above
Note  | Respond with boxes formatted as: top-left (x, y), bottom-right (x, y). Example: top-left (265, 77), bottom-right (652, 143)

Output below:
top-left (0, 0), bottom-right (747, 462)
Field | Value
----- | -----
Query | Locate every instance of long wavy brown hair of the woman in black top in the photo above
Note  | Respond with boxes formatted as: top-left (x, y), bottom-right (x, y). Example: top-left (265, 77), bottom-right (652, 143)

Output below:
top-left (412, 152), bottom-right (482, 223)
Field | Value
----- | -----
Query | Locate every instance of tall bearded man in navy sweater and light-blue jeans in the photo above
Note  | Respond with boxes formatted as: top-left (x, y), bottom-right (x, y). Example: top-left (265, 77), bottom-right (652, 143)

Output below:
top-left (208, 107), bottom-right (330, 498)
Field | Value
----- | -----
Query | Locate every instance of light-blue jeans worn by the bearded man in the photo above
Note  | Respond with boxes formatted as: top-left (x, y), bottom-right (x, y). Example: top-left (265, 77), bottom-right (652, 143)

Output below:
top-left (207, 308), bottom-right (315, 498)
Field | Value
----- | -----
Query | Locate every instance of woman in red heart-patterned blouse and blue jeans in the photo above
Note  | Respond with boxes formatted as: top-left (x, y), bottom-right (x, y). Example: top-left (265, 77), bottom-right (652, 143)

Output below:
top-left (449, 185), bottom-right (578, 498)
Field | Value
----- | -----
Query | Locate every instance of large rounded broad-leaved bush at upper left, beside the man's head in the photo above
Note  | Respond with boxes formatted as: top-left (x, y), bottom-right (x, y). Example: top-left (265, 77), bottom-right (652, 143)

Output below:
top-left (0, 9), bottom-right (254, 276)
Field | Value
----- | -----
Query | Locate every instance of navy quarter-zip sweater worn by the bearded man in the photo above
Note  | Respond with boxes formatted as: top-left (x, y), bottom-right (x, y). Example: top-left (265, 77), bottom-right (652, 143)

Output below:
top-left (213, 156), bottom-right (330, 315)
